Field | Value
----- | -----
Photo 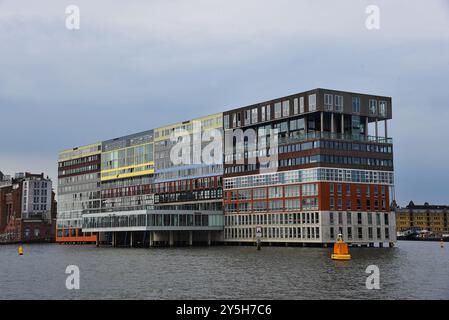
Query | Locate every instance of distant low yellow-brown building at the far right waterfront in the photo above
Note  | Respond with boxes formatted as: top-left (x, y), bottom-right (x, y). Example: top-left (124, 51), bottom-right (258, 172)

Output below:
top-left (396, 201), bottom-right (449, 235)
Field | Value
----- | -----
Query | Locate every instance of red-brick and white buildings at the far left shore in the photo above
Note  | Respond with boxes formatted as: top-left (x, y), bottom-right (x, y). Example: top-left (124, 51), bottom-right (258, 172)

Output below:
top-left (0, 173), bottom-right (56, 243)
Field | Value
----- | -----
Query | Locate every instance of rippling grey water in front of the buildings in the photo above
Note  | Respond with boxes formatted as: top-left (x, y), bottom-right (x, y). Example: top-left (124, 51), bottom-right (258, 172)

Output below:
top-left (0, 241), bottom-right (449, 299)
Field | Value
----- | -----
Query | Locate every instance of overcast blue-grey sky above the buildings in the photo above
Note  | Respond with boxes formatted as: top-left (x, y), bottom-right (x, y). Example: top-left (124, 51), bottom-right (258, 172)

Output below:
top-left (0, 0), bottom-right (449, 205)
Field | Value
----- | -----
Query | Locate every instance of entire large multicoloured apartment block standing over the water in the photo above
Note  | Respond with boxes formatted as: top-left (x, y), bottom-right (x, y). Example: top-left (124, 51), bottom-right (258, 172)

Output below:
top-left (58, 89), bottom-right (396, 246)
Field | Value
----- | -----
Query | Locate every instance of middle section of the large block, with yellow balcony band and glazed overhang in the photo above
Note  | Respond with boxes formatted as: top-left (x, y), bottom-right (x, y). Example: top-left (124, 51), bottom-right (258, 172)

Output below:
top-left (78, 114), bottom-right (223, 246)
